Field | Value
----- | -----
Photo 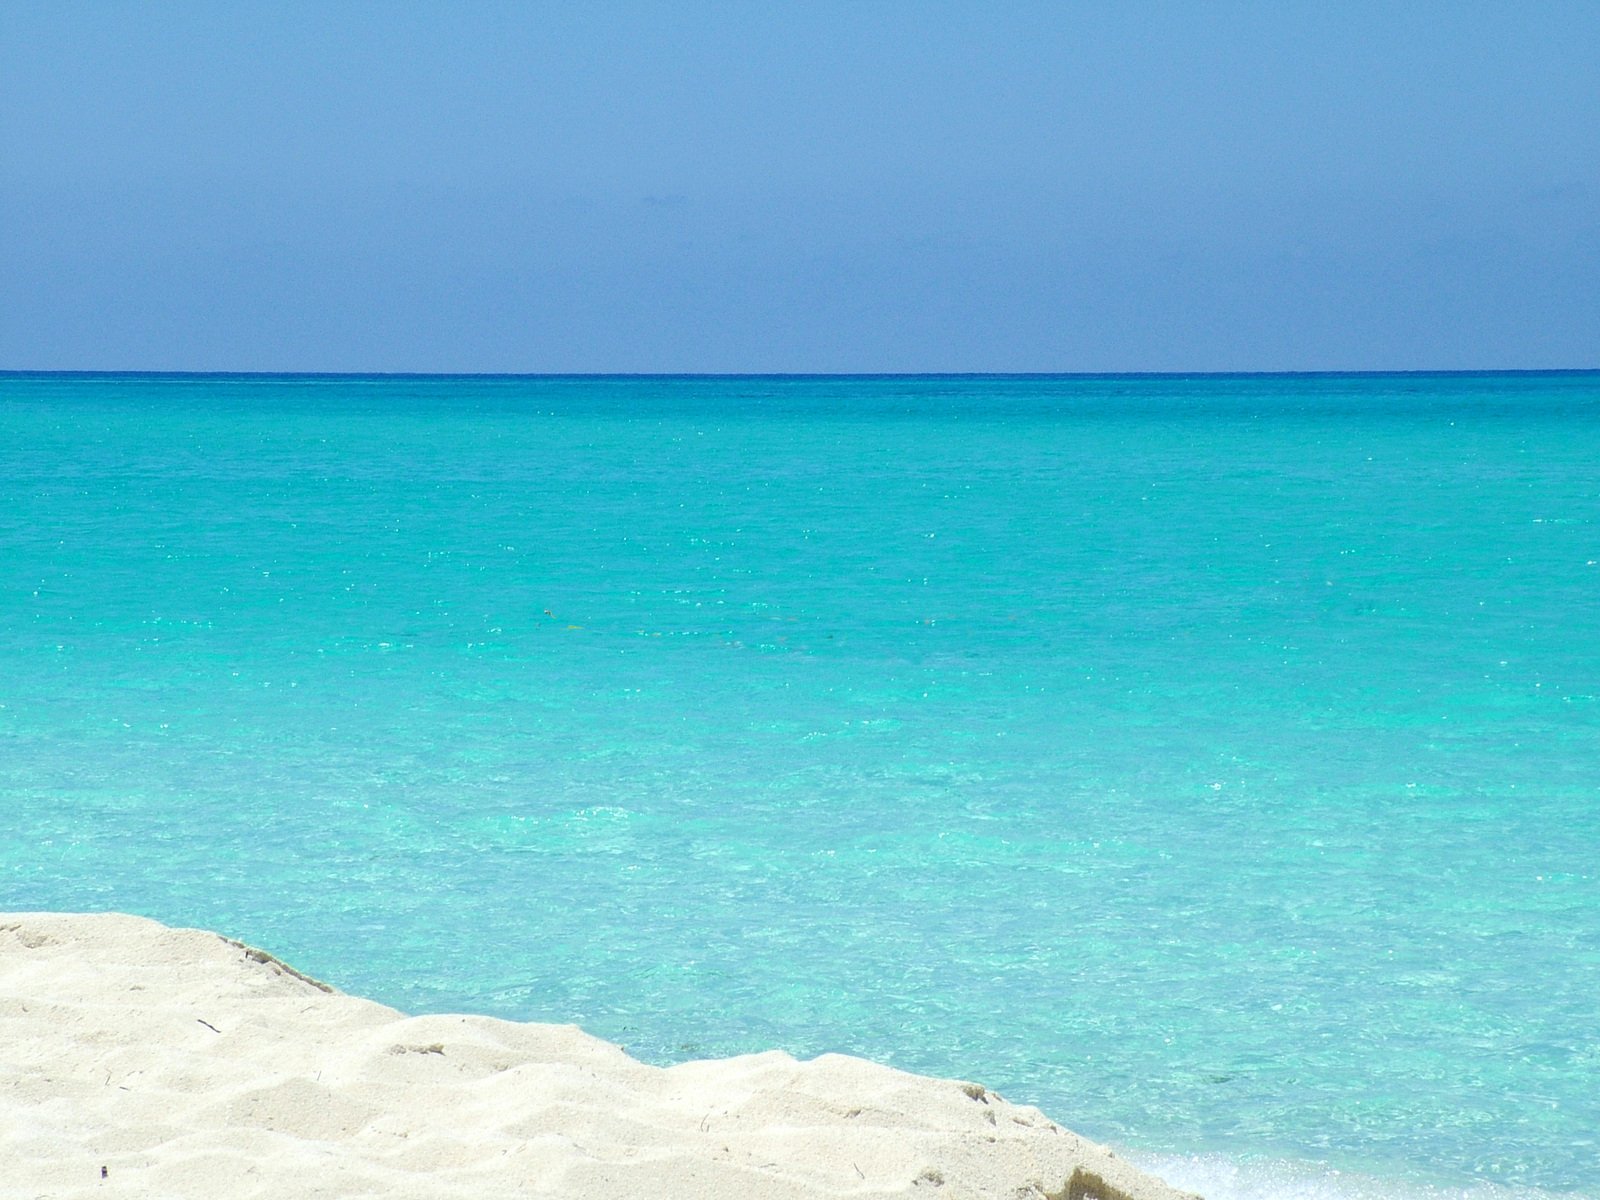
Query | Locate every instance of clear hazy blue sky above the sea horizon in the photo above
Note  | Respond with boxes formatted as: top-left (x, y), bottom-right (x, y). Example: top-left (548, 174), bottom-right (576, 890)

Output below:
top-left (0, 0), bottom-right (1600, 373)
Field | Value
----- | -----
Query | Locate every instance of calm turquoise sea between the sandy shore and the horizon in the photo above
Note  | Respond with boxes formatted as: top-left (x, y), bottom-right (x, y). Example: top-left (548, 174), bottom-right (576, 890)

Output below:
top-left (0, 374), bottom-right (1600, 1197)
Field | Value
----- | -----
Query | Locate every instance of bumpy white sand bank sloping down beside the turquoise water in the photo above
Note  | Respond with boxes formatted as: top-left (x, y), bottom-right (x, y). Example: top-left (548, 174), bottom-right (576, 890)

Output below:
top-left (0, 914), bottom-right (1203, 1200)
